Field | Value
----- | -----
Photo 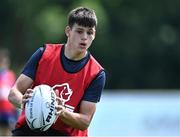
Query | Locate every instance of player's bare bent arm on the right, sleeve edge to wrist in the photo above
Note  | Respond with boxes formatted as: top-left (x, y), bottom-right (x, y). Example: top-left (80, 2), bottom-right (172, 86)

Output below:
top-left (56, 101), bottom-right (96, 130)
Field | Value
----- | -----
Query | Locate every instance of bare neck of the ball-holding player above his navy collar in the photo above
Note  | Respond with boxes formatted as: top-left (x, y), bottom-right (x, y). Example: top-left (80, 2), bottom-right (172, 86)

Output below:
top-left (64, 44), bottom-right (87, 61)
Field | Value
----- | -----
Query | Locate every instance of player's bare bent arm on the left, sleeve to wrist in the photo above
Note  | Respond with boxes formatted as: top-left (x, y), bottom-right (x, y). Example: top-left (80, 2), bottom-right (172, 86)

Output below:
top-left (8, 74), bottom-right (33, 108)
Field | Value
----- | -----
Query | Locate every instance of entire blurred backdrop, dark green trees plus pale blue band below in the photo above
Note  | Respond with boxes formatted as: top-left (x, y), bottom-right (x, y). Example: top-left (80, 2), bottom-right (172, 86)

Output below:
top-left (0, 0), bottom-right (180, 136)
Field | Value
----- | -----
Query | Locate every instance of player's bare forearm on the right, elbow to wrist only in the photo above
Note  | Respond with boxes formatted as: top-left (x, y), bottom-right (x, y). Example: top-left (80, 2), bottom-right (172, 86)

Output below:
top-left (60, 110), bottom-right (91, 130)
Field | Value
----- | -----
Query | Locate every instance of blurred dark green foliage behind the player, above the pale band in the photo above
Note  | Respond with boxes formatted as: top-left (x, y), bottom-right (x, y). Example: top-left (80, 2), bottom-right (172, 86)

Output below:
top-left (0, 0), bottom-right (180, 89)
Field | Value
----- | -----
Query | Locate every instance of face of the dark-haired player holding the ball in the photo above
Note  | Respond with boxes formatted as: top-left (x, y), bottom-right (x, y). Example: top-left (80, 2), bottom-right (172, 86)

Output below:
top-left (66, 24), bottom-right (96, 52)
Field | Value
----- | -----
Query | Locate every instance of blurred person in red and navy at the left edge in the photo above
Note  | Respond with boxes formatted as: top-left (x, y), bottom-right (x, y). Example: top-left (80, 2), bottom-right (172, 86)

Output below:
top-left (0, 49), bottom-right (16, 136)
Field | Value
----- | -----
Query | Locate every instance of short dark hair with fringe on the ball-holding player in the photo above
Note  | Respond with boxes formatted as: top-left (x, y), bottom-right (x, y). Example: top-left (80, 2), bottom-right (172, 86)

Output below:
top-left (68, 7), bottom-right (97, 27)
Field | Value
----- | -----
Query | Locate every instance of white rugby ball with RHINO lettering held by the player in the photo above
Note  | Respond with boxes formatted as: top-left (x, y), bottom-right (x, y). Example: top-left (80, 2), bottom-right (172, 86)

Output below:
top-left (25, 85), bottom-right (57, 131)
